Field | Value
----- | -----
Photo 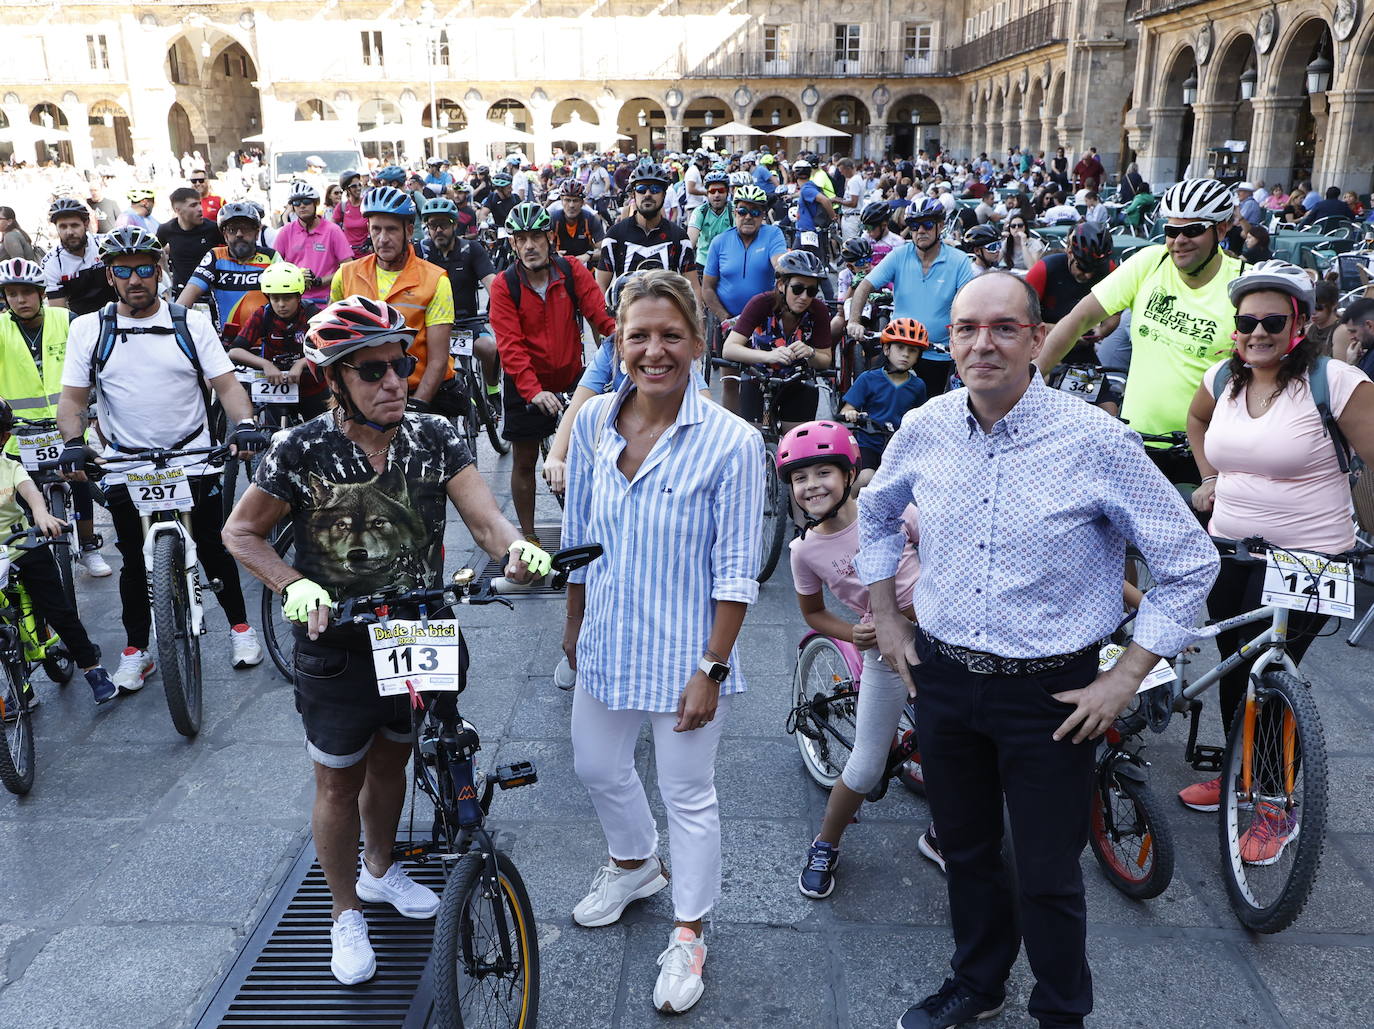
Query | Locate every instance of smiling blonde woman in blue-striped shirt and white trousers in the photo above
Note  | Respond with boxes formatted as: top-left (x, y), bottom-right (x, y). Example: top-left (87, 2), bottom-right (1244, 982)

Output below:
top-left (563, 271), bottom-right (764, 1013)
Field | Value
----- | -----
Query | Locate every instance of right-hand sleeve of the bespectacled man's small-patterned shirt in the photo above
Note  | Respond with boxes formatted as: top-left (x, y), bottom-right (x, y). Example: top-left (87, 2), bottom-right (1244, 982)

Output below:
top-left (1102, 433), bottom-right (1220, 657)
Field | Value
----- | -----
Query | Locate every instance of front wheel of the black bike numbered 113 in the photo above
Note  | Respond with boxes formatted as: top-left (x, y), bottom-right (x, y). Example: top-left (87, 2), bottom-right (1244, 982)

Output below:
top-left (431, 850), bottom-right (539, 1029)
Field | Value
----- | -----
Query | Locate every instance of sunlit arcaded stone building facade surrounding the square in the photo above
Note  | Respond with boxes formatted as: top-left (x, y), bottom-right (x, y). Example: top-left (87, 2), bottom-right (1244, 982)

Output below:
top-left (0, 0), bottom-right (1374, 190)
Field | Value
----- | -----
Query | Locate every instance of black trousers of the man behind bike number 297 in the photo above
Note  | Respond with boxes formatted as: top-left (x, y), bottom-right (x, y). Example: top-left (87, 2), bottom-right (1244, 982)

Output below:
top-left (104, 474), bottom-right (249, 650)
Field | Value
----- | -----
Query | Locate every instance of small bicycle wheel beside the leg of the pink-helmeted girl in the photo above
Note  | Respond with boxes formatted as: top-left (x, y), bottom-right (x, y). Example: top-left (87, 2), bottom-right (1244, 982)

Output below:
top-left (793, 636), bottom-right (859, 790)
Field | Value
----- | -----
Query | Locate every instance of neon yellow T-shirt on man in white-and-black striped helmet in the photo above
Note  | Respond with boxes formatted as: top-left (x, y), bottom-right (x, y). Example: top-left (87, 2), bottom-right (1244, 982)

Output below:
top-left (1092, 245), bottom-right (1242, 433)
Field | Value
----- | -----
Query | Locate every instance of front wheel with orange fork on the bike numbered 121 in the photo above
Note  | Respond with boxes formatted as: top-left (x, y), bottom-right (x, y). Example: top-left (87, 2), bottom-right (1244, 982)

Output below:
top-left (1217, 668), bottom-right (1327, 933)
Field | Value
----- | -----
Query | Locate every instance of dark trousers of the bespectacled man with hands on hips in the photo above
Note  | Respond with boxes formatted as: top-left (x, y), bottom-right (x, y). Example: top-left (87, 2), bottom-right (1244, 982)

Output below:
top-left (916, 632), bottom-right (1098, 1026)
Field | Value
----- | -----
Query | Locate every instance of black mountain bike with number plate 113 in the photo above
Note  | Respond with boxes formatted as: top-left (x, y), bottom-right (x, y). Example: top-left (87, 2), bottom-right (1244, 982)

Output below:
top-left (338, 544), bottom-right (602, 1029)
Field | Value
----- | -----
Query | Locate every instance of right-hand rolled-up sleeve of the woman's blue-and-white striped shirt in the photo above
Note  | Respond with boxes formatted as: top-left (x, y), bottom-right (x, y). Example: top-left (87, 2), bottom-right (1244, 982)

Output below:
top-left (710, 433), bottom-right (764, 604)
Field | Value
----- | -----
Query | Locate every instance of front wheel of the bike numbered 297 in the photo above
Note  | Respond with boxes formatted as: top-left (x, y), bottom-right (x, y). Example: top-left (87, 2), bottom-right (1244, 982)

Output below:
top-left (153, 533), bottom-right (201, 739)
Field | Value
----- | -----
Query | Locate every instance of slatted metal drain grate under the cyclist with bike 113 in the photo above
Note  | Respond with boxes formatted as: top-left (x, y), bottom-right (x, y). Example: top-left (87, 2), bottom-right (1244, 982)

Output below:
top-left (196, 842), bottom-right (444, 1029)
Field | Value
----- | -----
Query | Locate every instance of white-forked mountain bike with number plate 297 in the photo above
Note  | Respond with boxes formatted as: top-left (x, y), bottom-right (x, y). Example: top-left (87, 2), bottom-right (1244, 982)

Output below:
top-left (77, 445), bottom-right (229, 739)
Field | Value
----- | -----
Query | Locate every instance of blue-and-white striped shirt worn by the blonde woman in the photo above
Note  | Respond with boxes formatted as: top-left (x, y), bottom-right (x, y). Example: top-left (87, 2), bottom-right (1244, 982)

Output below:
top-left (562, 381), bottom-right (764, 712)
